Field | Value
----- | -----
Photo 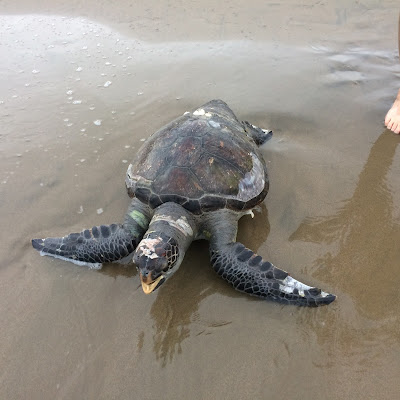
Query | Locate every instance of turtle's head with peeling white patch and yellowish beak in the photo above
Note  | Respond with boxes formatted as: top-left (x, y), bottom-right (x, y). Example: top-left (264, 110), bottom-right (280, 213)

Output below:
top-left (133, 232), bottom-right (182, 294)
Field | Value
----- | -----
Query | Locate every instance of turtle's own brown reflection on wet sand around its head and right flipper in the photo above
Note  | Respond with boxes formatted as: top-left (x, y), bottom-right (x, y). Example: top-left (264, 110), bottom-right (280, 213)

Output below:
top-left (142, 204), bottom-right (269, 366)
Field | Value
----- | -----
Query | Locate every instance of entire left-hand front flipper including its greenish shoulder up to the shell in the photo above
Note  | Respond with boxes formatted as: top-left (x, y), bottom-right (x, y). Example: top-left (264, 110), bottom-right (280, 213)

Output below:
top-left (32, 199), bottom-right (152, 269)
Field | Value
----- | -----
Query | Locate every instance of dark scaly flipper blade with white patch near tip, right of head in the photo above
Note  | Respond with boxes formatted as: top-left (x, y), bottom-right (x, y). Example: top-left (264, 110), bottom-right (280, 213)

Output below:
top-left (210, 243), bottom-right (336, 307)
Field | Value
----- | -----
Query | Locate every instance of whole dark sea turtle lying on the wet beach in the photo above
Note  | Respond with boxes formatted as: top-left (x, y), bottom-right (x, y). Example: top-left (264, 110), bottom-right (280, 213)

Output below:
top-left (32, 100), bottom-right (335, 306)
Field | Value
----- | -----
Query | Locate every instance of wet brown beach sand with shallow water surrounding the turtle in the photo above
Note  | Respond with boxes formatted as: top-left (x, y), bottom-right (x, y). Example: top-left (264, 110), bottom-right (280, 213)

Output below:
top-left (0, 0), bottom-right (400, 399)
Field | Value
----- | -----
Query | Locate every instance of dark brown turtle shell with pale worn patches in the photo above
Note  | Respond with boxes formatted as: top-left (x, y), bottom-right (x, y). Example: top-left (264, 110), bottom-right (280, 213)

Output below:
top-left (126, 100), bottom-right (269, 214)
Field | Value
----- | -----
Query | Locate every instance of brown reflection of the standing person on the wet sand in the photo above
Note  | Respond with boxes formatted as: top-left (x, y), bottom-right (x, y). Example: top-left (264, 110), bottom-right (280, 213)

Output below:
top-left (290, 131), bottom-right (400, 342)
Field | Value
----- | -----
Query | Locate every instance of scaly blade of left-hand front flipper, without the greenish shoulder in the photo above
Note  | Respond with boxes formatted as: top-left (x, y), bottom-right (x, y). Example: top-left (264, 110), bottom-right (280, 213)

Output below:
top-left (32, 224), bottom-right (140, 269)
